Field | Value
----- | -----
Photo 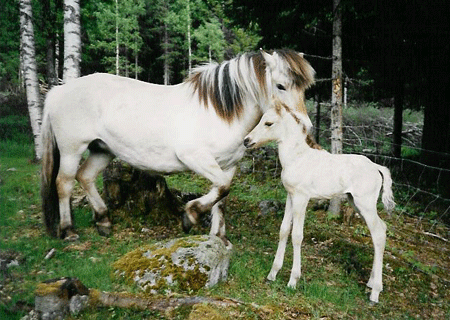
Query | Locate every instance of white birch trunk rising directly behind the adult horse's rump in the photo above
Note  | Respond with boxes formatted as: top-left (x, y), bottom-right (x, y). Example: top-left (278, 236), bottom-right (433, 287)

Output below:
top-left (63, 0), bottom-right (81, 82)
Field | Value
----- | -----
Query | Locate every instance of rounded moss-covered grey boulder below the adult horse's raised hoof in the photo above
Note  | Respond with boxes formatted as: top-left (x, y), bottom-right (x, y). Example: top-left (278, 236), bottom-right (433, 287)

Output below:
top-left (113, 235), bottom-right (231, 293)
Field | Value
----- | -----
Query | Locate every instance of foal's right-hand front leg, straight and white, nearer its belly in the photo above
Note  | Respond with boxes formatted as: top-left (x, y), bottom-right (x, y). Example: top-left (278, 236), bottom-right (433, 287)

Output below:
top-left (288, 195), bottom-right (309, 288)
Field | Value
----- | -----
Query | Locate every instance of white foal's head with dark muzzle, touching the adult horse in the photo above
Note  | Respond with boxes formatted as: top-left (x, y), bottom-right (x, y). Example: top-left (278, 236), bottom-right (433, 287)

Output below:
top-left (244, 100), bottom-right (312, 148)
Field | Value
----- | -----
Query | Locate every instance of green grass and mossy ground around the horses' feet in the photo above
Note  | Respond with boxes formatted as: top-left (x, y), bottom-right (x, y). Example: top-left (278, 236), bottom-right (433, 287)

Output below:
top-left (0, 107), bottom-right (450, 319)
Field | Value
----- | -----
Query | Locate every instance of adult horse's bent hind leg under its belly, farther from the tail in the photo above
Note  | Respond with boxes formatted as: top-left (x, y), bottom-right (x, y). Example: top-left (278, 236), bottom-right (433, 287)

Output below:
top-left (76, 150), bottom-right (113, 236)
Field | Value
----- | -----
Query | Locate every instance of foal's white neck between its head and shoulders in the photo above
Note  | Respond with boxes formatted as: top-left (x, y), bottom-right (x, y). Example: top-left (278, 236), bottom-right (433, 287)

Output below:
top-left (278, 134), bottom-right (312, 168)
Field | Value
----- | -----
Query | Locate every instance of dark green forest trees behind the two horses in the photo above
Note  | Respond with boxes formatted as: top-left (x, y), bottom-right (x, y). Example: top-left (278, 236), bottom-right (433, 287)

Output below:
top-left (0, 0), bottom-right (450, 170)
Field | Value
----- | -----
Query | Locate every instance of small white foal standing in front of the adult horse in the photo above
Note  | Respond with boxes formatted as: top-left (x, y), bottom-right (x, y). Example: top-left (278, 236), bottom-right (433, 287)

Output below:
top-left (244, 103), bottom-right (395, 302)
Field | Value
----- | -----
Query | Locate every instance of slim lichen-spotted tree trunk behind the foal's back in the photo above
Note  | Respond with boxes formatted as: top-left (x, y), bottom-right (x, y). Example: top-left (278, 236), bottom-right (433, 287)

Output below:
top-left (328, 0), bottom-right (343, 216)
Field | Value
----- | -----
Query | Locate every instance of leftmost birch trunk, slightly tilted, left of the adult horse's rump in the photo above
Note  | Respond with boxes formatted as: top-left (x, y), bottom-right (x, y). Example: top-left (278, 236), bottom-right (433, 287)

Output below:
top-left (19, 0), bottom-right (42, 160)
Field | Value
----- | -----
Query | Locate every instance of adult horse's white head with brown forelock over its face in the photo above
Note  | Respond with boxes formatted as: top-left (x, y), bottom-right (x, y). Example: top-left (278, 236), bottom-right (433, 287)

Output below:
top-left (261, 50), bottom-right (315, 115)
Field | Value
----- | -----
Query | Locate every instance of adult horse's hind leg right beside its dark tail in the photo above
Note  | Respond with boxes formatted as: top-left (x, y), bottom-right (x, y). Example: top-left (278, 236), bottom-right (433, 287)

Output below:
top-left (56, 154), bottom-right (81, 241)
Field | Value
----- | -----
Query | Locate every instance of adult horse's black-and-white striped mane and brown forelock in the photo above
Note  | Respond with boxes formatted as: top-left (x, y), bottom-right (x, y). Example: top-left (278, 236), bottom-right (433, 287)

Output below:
top-left (186, 49), bottom-right (314, 122)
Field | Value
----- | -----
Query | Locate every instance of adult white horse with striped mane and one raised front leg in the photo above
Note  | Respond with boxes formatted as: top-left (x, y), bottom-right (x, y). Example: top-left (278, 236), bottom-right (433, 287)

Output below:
top-left (41, 50), bottom-right (314, 240)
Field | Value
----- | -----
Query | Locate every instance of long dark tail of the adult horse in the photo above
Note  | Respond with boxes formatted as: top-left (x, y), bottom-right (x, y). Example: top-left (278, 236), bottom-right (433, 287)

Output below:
top-left (41, 109), bottom-right (60, 237)
